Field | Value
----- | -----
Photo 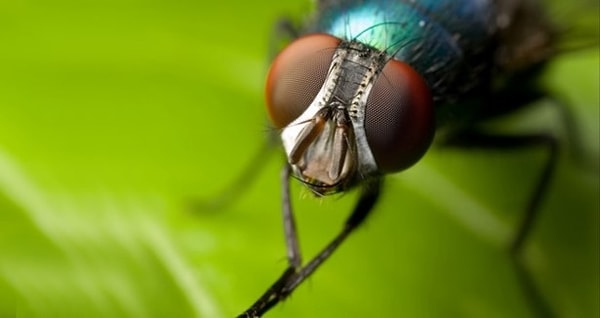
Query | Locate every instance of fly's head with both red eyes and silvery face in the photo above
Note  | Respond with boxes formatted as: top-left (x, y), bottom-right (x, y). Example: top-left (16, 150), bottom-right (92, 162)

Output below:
top-left (267, 34), bottom-right (434, 195)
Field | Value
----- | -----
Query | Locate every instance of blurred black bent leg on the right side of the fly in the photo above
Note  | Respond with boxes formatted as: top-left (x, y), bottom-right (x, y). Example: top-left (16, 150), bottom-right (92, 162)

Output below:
top-left (446, 131), bottom-right (558, 317)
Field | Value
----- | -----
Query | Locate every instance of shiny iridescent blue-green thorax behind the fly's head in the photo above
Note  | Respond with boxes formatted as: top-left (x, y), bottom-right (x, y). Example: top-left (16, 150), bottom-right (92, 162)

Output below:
top-left (307, 0), bottom-right (496, 100)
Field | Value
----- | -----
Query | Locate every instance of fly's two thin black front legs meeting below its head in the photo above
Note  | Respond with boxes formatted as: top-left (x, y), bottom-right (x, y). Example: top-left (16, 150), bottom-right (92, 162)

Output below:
top-left (238, 175), bottom-right (381, 318)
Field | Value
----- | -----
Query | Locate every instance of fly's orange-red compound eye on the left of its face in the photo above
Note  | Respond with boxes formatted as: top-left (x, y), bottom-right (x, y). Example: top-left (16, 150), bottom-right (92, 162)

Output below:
top-left (266, 34), bottom-right (340, 128)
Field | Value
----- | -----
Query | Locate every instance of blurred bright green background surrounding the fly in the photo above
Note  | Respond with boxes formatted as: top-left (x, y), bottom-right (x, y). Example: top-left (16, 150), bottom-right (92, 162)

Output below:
top-left (0, 0), bottom-right (600, 317)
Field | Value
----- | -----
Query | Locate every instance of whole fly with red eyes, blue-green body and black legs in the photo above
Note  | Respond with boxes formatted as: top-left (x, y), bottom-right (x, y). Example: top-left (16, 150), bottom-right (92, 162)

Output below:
top-left (240, 0), bottom-right (580, 317)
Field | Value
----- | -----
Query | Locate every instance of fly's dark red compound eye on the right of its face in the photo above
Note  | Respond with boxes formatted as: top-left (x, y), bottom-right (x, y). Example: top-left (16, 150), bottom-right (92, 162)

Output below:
top-left (365, 60), bottom-right (435, 173)
